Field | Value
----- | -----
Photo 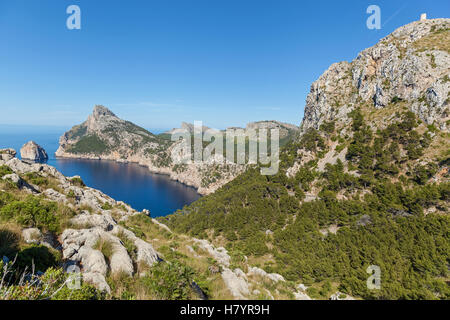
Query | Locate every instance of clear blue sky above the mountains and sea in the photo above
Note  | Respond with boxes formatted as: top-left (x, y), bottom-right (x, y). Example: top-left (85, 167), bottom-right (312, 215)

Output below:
top-left (0, 0), bottom-right (450, 129)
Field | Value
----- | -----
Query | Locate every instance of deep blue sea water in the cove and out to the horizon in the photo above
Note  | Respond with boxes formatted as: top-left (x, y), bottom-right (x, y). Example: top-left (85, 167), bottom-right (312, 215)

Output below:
top-left (0, 126), bottom-right (200, 217)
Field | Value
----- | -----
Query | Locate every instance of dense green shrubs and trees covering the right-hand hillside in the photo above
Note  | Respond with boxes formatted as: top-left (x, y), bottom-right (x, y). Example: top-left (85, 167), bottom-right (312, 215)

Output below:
top-left (163, 109), bottom-right (450, 299)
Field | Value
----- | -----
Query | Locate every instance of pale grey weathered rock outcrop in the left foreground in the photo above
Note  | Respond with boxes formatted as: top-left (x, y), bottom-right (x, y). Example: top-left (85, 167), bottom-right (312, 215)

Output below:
top-left (0, 149), bottom-right (160, 293)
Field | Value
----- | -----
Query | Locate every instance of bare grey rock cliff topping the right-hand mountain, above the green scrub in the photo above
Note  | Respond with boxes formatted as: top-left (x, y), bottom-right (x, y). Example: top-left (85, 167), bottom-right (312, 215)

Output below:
top-left (302, 19), bottom-right (450, 132)
